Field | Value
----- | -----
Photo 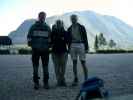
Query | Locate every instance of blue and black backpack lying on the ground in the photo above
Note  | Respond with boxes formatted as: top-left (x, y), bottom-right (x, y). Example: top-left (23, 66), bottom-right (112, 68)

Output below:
top-left (76, 77), bottom-right (108, 100)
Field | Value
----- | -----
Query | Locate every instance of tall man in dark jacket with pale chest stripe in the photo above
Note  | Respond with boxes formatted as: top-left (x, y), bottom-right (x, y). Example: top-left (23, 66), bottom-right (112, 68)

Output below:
top-left (27, 12), bottom-right (51, 89)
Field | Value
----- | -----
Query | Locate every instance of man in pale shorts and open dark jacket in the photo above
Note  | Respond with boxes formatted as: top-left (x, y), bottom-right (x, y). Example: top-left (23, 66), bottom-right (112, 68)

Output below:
top-left (68, 15), bottom-right (88, 86)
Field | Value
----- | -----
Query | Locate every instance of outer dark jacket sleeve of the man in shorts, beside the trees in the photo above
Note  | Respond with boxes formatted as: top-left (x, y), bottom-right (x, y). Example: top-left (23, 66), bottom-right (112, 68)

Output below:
top-left (81, 26), bottom-right (89, 51)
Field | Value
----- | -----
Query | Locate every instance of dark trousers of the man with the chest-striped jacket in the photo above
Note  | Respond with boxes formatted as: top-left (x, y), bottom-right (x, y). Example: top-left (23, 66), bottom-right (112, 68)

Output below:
top-left (32, 49), bottom-right (49, 83)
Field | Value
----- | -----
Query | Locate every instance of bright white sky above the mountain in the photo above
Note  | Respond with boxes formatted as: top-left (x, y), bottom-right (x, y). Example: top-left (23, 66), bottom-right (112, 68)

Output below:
top-left (0, 0), bottom-right (133, 35)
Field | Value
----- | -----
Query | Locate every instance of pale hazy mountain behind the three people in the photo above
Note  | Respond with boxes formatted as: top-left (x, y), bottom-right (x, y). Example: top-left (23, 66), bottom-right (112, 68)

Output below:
top-left (9, 11), bottom-right (133, 50)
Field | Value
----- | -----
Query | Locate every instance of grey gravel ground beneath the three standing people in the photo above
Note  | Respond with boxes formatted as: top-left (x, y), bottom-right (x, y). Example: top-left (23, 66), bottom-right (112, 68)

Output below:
top-left (0, 54), bottom-right (133, 100)
